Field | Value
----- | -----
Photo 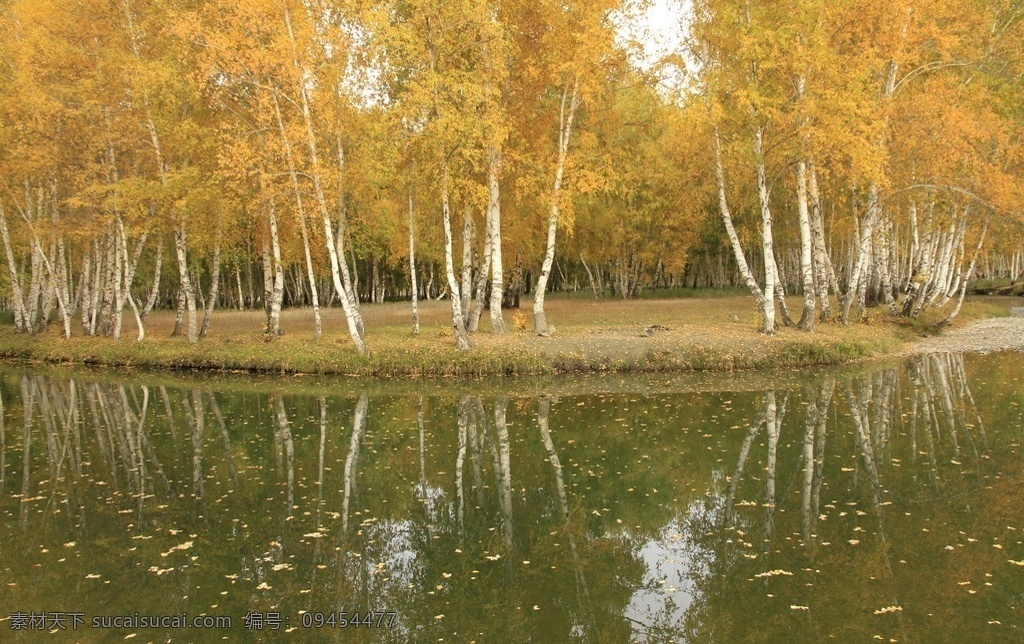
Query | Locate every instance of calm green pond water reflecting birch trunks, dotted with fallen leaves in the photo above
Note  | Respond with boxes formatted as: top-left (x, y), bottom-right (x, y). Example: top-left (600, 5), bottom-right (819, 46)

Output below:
top-left (0, 353), bottom-right (1024, 642)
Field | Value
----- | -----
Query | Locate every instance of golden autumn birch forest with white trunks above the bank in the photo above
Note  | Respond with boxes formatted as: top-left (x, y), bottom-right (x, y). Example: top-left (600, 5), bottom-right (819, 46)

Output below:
top-left (0, 0), bottom-right (1024, 353)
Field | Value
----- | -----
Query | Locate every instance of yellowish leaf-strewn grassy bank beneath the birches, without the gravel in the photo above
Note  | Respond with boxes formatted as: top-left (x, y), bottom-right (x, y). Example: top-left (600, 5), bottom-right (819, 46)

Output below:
top-left (0, 296), bottom-right (1010, 377)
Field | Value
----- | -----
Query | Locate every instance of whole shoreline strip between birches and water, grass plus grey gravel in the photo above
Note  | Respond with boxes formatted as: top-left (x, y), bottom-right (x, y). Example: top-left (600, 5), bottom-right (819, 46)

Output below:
top-left (0, 299), bottom-right (1024, 378)
